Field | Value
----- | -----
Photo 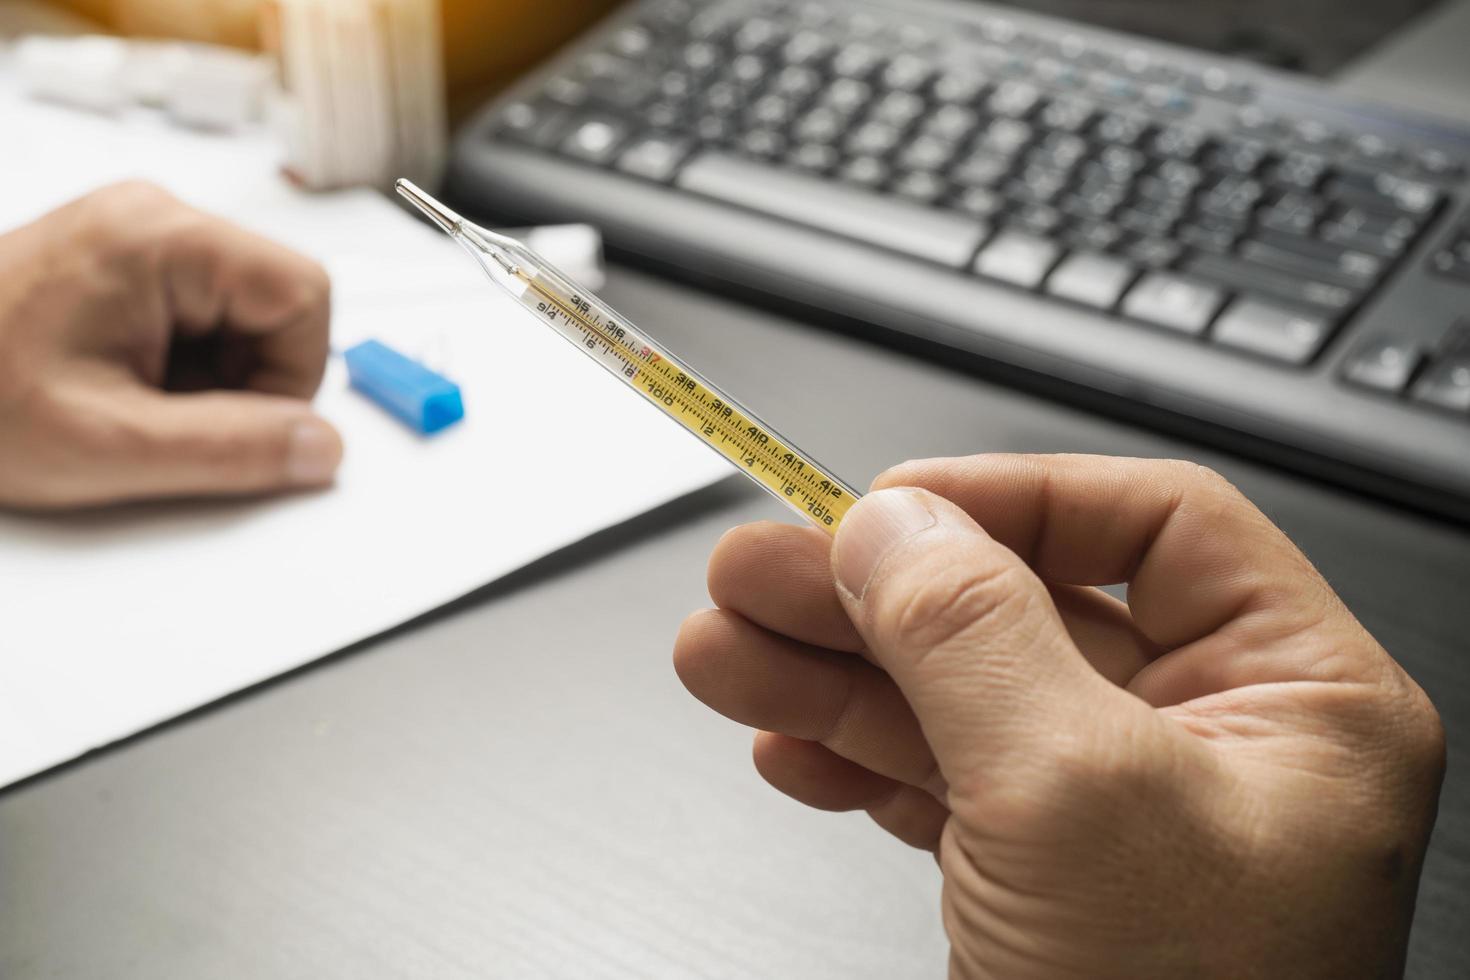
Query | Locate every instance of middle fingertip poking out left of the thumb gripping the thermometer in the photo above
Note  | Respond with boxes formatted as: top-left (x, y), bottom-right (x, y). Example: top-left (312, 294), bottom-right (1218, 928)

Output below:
top-left (709, 522), bottom-right (863, 652)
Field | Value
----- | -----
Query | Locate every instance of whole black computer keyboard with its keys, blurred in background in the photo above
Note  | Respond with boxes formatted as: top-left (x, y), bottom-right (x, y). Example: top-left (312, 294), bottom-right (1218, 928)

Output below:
top-left (450, 0), bottom-right (1470, 517)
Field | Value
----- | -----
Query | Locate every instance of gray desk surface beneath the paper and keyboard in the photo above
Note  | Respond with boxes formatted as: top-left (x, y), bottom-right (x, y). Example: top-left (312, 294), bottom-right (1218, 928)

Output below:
top-left (0, 3), bottom-right (1470, 980)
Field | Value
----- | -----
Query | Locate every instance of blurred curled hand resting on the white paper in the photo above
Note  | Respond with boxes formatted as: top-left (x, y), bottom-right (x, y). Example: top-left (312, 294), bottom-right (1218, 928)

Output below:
top-left (0, 184), bottom-right (343, 510)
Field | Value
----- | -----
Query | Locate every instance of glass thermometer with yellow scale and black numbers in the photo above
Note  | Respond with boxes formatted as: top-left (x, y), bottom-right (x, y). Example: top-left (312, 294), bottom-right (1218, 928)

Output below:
top-left (397, 181), bottom-right (857, 533)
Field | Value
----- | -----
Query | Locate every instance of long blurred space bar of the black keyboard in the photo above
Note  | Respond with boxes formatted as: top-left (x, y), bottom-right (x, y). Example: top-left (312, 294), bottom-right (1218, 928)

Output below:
top-left (675, 153), bottom-right (986, 269)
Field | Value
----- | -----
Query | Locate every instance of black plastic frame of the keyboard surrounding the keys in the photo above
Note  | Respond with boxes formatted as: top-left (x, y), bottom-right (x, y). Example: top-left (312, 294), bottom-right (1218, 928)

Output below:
top-left (447, 0), bottom-right (1470, 520)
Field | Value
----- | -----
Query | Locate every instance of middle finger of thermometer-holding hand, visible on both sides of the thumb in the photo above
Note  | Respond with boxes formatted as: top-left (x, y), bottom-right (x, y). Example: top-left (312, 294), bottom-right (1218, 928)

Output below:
top-left (709, 522), bottom-right (1161, 685)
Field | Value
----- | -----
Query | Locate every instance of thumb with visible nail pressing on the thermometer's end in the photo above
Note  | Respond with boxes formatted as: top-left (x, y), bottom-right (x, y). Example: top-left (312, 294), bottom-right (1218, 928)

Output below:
top-left (832, 489), bottom-right (1126, 785)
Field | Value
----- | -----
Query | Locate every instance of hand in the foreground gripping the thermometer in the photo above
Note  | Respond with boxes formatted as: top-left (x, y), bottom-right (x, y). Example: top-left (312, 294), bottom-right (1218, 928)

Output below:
top-left (675, 455), bottom-right (1444, 979)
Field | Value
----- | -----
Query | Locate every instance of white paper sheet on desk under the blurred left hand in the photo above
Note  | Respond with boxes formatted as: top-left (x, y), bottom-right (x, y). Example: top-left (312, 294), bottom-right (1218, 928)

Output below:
top-left (0, 71), bottom-right (731, 786)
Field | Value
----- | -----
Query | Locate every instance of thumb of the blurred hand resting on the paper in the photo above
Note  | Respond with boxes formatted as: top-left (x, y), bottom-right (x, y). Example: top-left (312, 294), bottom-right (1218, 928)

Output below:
top-left (97, 389), bottom-right (343, 500)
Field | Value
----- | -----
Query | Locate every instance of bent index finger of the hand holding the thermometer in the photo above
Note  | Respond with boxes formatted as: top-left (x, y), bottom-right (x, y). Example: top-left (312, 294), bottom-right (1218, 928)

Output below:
top-left (875, 455), bottom-right (1333, 658)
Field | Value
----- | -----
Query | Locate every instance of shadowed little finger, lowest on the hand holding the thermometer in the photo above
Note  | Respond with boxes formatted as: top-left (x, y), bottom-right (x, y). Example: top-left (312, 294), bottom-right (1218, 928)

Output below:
top-left (754, 732), bottom-right (950, 851)
